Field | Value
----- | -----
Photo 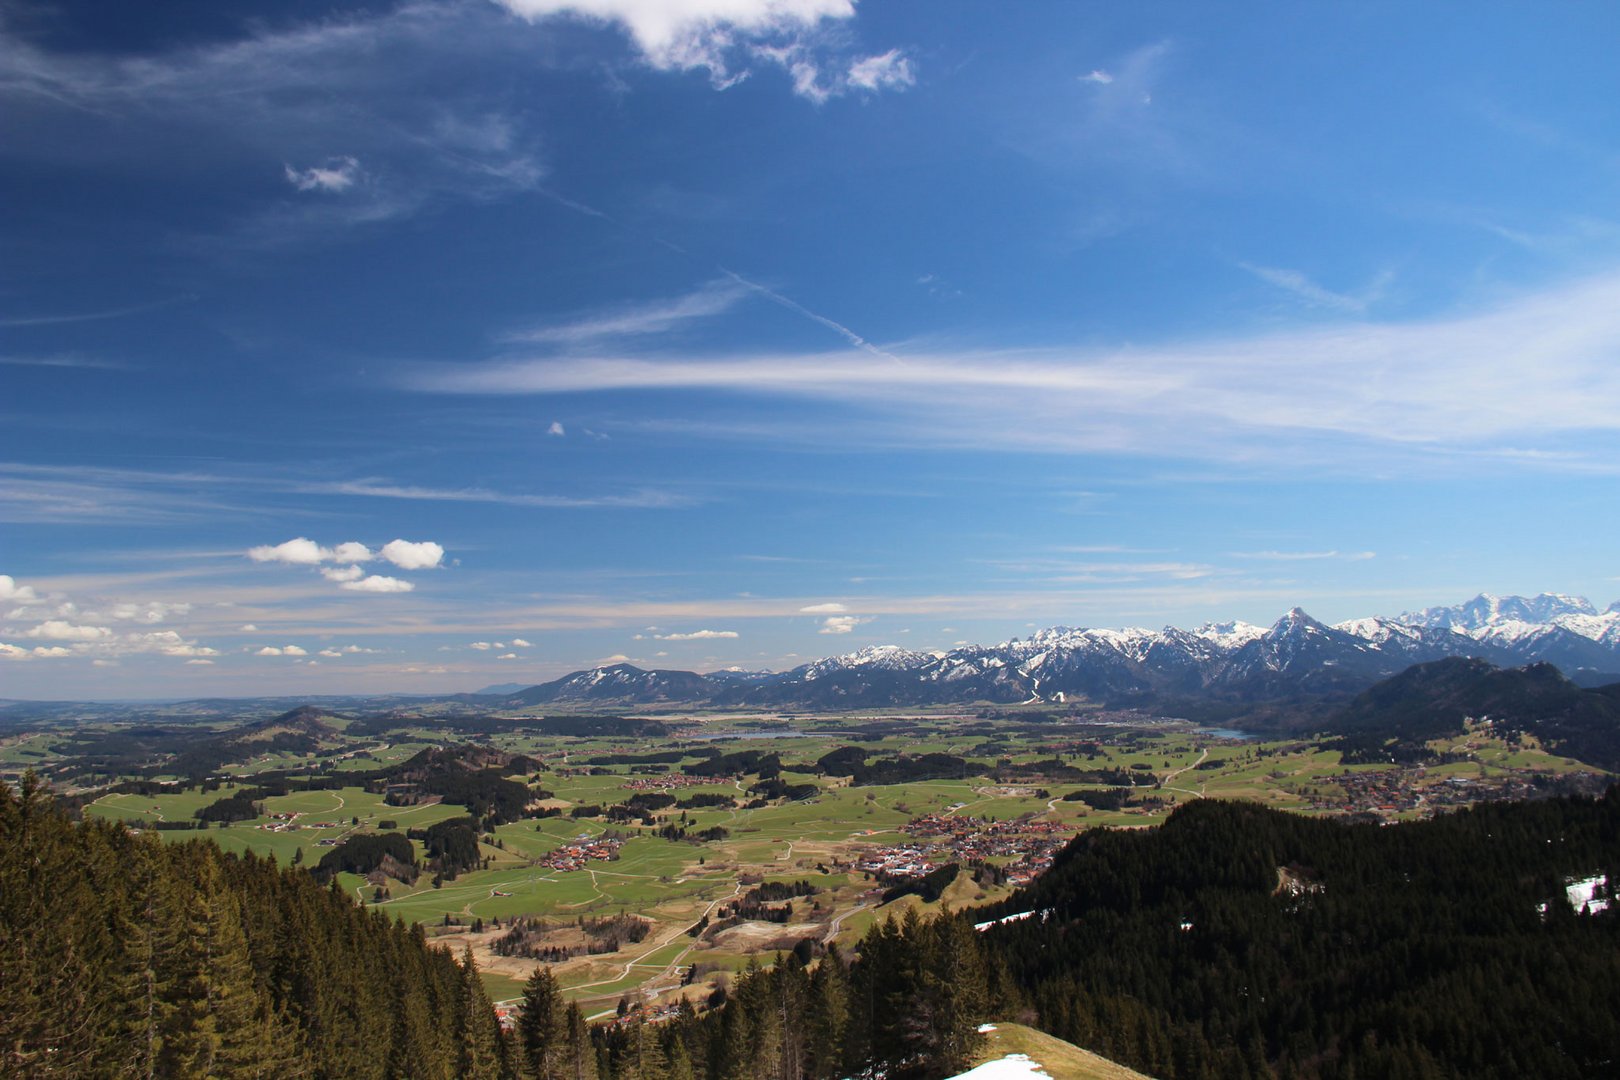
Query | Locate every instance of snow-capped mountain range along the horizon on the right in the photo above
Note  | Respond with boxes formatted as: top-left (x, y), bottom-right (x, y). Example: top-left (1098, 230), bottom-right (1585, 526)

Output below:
top-left (510, 593), bottom-right (1620, 708)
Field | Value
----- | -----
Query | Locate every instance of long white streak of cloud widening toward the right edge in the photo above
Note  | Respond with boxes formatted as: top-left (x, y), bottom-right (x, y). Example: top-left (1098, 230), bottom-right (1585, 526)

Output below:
top-left (410, 274), bottom-right (1620, 471)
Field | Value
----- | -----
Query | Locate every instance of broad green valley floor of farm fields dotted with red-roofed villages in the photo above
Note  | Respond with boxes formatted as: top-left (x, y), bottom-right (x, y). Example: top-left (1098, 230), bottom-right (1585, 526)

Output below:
top-left (22, 714), bottom-right (1607, 1015)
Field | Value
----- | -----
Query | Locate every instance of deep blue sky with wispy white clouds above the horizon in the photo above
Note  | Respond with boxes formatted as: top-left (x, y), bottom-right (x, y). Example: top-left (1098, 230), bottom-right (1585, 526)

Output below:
top-left (0, 0), bottom-right (1620, 698)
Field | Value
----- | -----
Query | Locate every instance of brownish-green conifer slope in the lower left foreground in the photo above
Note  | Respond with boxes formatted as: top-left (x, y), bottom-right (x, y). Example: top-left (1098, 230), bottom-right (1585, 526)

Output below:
top-left (0, 779), bottom-right (504, 1078)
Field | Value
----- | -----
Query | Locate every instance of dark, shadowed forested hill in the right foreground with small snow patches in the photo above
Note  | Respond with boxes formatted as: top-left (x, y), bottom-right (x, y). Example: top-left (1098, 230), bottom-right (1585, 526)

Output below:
top-left (977, 787), bottom-right (1620, 1080)
